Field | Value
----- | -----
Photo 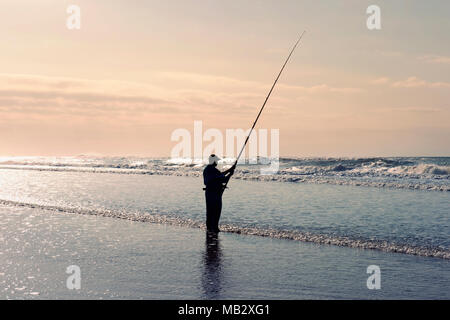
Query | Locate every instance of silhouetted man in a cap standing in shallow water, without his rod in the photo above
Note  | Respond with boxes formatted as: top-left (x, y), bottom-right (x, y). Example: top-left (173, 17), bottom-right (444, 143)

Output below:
top-left (203, 154), bottom-right (236, 233)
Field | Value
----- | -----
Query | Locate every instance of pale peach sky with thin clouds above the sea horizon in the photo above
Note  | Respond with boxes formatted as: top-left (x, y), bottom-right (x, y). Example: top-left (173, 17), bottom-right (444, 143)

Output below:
top-left (0, 0), bottom-right (450, 157)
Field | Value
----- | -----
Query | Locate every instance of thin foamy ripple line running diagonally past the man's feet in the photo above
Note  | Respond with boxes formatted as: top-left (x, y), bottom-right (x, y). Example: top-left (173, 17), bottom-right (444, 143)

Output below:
top-left (0, 200), bottom-right (450, 259)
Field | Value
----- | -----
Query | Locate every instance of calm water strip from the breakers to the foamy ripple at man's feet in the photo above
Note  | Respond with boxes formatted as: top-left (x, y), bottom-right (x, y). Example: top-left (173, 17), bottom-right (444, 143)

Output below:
top-left (0, 170), bottom-right (450, 259)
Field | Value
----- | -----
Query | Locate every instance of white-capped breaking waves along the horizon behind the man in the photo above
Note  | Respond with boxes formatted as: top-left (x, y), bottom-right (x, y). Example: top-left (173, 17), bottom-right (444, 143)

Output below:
top-left (0, 156), bottom-right (450, 191)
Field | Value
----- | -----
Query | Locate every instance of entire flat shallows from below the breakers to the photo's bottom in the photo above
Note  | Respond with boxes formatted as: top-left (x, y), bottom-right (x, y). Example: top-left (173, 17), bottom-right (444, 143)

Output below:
top-left (0, 168), bottom-right (450, 299)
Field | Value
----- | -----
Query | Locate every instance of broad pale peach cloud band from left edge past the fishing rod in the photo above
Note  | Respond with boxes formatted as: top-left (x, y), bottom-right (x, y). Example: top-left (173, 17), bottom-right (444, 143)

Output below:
top-left (0, 73), bottom-right (364, 118)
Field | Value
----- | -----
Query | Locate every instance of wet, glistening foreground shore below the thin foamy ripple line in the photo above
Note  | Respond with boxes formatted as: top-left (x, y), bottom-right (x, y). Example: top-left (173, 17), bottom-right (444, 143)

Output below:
top-left (0, 206), bottom-right (450, 299)
